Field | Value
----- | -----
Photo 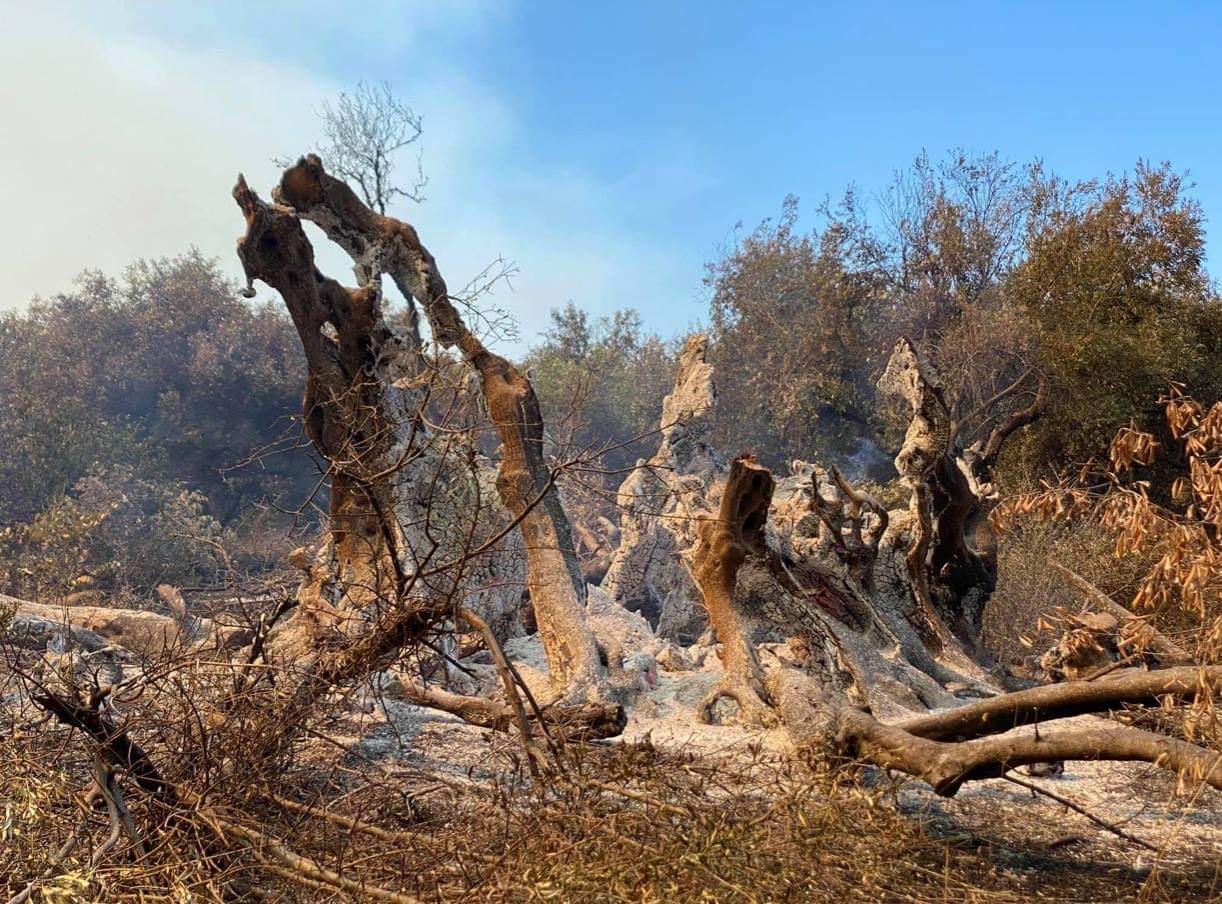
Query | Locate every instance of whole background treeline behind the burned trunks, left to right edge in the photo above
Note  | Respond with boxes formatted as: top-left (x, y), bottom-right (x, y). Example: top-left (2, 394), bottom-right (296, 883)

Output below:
top-left (0, 154), bottom-right (1222, 596)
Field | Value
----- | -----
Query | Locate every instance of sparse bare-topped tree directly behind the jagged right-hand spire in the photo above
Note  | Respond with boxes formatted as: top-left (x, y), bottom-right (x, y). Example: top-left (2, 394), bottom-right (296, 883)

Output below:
top-left (822, 150), bottom-right (1045, 459)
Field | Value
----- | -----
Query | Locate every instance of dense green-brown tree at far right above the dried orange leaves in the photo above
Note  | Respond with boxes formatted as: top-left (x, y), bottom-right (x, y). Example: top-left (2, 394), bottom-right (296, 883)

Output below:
top-left (1004, 164), bottom-right (1222, 462)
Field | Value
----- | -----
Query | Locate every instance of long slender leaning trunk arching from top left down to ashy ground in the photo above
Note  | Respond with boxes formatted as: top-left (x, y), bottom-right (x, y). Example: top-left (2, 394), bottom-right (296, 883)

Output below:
top-left (274, 155), bottom-right (605, 700)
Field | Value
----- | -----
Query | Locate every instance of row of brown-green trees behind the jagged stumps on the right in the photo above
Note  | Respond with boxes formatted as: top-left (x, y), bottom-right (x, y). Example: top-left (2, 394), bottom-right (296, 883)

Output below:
top-left (706, 151), bottom-right (1222, 474)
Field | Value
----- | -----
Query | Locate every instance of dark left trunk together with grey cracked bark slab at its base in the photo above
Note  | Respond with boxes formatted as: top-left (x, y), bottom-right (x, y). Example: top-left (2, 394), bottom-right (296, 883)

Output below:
top-left (235, 174), bottom-right (524, 652)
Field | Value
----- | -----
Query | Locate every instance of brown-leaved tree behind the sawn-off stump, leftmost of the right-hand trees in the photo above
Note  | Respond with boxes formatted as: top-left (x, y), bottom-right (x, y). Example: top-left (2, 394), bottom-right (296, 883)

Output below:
top-left (705, 197), bottom-right (882, 465)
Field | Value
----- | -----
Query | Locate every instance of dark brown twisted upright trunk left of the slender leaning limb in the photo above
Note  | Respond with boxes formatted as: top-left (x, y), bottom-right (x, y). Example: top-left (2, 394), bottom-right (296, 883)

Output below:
top-left (233, 177), bottom-right (425, 643)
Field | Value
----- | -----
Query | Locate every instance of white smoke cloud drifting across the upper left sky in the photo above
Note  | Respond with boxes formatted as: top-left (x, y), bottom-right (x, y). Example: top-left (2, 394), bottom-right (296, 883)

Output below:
top-left (0, 4), bottom-right (699, 349)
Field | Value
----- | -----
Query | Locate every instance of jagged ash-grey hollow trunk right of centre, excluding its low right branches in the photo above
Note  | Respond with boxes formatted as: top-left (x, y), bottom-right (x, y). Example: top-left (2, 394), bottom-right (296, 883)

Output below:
top-left (604, 337), bottom-right (1070, 722)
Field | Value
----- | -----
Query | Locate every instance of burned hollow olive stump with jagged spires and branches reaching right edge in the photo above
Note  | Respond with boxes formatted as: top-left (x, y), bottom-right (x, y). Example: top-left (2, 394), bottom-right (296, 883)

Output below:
top-left (604, 337), bottom-right (1222, 794)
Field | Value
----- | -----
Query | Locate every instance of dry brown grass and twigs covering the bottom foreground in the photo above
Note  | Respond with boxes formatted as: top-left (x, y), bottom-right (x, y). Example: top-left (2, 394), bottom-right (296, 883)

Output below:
top-left (0, 718), bottom-right (1220, 904)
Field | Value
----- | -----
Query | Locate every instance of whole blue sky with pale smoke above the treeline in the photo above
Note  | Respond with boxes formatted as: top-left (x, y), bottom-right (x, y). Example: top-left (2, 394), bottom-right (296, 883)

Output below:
top-left (0, 0), bottom-right (1222, 340)
